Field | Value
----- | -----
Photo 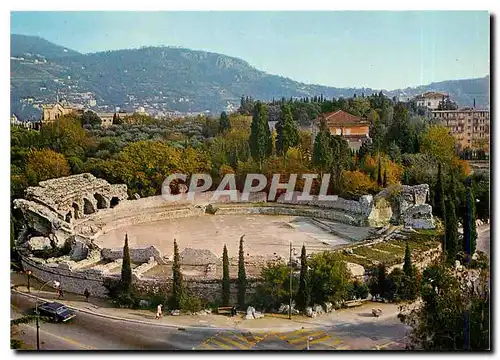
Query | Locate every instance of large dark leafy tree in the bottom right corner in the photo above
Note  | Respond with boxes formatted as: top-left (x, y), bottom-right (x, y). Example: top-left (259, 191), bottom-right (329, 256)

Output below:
top-left (398, 264), bottom-right (490, 351)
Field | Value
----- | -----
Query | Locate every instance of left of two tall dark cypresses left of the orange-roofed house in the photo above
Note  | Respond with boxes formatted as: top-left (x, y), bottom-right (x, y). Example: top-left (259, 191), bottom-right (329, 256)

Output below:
top-left (248, 101), bottom-right (272, 169)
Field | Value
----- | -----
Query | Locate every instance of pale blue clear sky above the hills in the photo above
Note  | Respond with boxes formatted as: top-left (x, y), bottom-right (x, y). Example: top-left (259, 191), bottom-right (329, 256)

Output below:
top-left (11, 11), bottom-right (490, 90)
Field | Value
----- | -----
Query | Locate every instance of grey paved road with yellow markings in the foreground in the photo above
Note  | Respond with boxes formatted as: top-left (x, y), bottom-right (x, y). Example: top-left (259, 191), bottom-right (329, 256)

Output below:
top-left (11, 293), bottom-right (405, 350)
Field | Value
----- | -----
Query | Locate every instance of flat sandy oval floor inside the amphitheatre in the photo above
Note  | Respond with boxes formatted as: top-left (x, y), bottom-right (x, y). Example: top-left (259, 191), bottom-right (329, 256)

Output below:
top-left (96, 215), bottom-right (349, 258)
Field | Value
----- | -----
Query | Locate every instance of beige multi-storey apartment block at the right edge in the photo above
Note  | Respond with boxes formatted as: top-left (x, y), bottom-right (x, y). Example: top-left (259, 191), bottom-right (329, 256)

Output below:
top-left (432, 108), bottom-right (490, 153)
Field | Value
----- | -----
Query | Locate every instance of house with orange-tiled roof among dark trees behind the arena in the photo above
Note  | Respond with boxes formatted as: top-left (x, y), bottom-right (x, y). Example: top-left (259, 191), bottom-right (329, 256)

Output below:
top-left (312, 110), bottom-right (370, 151)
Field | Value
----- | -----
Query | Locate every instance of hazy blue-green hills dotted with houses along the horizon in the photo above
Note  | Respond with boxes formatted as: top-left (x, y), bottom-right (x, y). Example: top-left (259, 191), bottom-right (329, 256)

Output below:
top-left (11, 35), bottom-right (487, 117)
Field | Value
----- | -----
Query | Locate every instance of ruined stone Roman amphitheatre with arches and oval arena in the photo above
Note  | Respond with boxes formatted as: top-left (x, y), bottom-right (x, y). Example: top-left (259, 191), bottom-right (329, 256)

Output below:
top-left (14, 173), bottom-right (435, 299)
